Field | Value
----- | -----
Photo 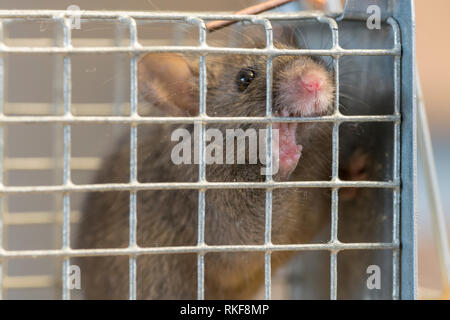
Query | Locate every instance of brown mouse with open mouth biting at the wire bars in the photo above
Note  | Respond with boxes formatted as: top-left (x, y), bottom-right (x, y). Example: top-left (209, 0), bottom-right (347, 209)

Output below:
top-left (76, 38), bottom-right (340, 299)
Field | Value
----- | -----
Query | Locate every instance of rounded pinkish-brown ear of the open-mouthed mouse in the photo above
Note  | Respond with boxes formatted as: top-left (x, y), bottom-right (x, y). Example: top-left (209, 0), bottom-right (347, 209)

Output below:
top-left (138, 53), bottom-right (199, 116)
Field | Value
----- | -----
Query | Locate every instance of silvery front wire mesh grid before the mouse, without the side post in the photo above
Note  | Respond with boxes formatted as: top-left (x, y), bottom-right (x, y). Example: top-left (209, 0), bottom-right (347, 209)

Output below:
top-left (0, 11), bottom-right (401, 299)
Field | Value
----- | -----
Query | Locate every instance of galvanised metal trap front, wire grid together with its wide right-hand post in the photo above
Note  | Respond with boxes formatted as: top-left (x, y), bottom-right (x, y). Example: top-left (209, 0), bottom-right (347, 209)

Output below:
top-left (0, 1), bottom-right (417, 299)
